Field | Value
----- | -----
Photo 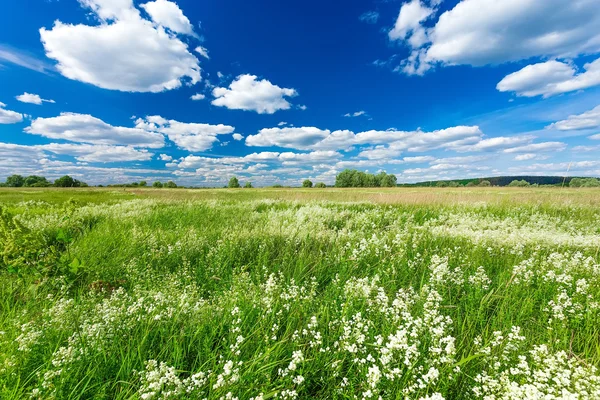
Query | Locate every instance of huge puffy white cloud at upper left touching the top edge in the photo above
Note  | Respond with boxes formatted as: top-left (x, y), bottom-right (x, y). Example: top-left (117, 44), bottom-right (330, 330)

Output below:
top-left (40, 0), bottom-right (201, 92)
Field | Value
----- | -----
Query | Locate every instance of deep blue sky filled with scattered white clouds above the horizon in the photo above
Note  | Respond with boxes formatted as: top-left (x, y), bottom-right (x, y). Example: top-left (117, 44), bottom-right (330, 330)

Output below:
top-left (0, 0), bottom-right (600, 186)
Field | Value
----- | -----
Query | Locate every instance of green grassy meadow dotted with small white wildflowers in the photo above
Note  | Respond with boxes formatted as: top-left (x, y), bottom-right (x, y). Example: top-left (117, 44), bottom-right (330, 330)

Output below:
top-left (0, 188), bottom-right (600, 400)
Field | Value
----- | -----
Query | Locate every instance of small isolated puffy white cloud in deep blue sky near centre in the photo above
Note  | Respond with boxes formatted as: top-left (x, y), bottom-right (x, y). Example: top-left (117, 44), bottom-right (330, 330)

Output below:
top-left (212, 74), bottom-right (298, 114)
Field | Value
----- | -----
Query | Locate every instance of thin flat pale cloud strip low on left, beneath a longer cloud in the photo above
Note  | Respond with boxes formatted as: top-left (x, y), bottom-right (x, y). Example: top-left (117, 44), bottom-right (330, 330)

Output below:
top-left (36, 143), bottom-right (153, 163)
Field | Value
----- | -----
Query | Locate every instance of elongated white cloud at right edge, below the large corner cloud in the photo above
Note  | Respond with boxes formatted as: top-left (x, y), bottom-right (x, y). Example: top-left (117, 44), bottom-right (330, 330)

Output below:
top-left (496, 58), bottom-right (600, 98)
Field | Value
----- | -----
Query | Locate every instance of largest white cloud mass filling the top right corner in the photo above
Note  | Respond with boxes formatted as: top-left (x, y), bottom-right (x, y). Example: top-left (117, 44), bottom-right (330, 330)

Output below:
top-left (389, 0), bottom-right (600, 74)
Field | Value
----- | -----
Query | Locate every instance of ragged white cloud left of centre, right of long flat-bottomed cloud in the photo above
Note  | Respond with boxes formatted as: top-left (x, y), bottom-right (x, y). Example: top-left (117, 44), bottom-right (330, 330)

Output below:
top-left (136, 115), bottom-right (235, 151)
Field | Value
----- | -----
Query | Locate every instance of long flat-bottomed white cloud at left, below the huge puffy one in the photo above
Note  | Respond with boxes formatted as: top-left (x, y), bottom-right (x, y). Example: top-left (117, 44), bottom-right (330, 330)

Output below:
top-left (25, 113), bottom-right (164, 148)
